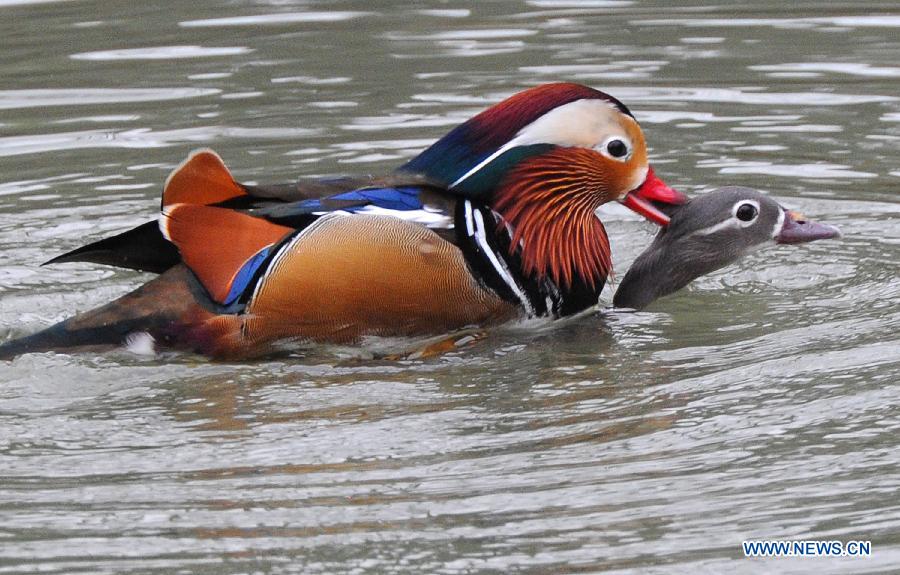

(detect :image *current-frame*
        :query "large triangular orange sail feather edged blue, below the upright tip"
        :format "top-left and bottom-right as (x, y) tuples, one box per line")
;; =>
(159, 204), (294, 303)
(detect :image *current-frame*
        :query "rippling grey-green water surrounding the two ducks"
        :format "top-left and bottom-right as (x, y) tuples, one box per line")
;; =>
(0, 0), (900, 574)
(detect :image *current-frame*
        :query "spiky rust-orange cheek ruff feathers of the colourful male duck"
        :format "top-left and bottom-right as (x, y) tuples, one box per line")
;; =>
(496, 148), (624, 288)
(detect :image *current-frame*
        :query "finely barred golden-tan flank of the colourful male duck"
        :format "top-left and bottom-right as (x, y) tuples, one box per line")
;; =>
(242, 214), (518, 346)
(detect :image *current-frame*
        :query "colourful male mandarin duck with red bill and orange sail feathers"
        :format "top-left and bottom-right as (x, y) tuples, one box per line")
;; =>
(0, 83), (685, 358)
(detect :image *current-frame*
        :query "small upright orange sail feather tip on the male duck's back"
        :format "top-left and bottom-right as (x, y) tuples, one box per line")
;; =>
(162, 149), (246, 208)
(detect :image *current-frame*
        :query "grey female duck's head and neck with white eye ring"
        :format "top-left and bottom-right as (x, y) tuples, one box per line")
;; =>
(613, 187), (840, 309)
